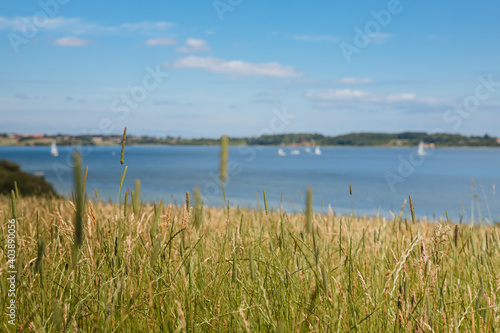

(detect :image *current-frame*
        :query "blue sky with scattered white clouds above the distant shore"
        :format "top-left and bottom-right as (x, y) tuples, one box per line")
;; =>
(0, 0), (500, 137)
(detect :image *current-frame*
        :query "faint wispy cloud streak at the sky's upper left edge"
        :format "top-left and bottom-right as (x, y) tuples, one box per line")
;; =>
(0, 16), (174, 35)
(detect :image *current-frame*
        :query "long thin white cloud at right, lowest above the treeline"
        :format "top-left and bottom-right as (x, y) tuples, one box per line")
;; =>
(306, 89), (450, 105)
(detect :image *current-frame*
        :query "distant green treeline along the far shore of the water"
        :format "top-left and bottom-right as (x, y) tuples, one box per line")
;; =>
(0, 132), (500, 147)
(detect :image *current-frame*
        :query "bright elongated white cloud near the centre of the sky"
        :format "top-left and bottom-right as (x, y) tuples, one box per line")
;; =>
(171, 56), (302, 77)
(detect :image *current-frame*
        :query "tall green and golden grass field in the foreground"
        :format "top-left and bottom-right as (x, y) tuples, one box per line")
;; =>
(0, 188), (500, 332)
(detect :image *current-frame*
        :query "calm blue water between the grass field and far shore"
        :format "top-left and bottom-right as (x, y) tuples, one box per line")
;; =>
(0, 146), (500, 221)
